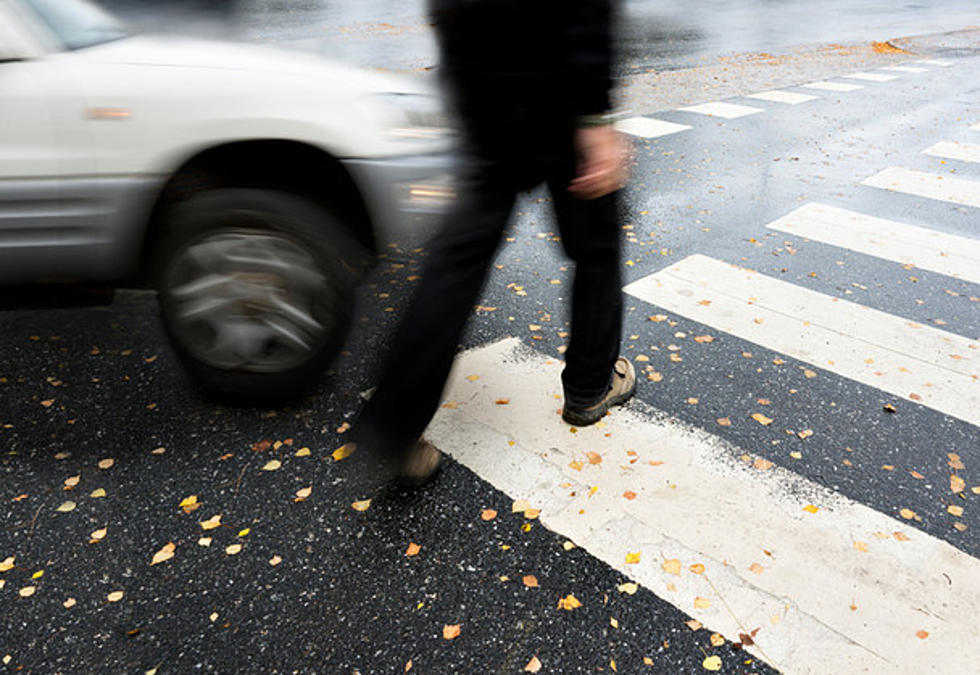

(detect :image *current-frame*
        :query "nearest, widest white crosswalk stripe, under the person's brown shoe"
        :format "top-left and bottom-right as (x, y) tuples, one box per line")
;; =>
(426, 339), (980, 675)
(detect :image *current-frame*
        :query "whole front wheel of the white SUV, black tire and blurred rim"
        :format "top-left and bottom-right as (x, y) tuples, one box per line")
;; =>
(153, 188), (364, 402)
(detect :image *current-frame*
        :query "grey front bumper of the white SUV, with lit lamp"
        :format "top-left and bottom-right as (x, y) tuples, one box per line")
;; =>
(343, 153), (458, 250)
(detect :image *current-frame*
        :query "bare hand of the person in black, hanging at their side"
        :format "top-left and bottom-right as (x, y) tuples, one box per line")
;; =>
(568, 125), (629, 199)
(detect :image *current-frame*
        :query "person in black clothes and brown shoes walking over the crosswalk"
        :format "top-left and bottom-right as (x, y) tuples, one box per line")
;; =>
(355, 0), (636, 484)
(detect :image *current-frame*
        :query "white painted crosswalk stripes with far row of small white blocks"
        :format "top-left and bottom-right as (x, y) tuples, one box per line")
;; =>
(442, 59), (980, 673)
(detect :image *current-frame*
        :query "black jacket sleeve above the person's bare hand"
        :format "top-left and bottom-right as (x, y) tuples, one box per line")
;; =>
(564, 0), (615, 116)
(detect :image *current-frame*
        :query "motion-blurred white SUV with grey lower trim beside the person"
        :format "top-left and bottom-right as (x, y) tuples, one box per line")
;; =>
(0, 0), (452, 398)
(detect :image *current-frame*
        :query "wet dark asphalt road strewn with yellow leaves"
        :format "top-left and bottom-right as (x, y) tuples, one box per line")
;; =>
(0, 5), (980, 673)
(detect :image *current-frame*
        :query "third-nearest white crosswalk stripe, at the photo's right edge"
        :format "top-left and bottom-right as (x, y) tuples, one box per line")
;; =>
(767, 203), (980, 284)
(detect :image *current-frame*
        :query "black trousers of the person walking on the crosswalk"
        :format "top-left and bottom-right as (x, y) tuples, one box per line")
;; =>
(355, 136), (623, 459)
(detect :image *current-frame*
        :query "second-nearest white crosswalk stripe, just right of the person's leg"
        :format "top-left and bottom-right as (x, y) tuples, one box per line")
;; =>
(624, 255), (980, 425)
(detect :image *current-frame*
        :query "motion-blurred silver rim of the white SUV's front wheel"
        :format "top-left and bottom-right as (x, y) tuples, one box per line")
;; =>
(161, 230), (337, 372)
